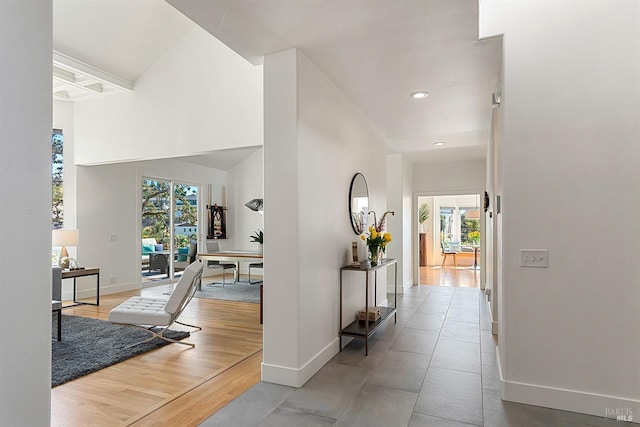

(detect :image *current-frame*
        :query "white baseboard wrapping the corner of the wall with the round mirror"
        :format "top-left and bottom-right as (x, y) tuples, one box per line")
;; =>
(262, 338), (340, 387)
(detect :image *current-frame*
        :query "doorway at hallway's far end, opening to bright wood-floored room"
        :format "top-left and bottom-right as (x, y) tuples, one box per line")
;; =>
(417, 194), (482, 288)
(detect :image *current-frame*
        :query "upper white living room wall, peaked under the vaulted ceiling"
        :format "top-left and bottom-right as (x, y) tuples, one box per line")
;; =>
(70, 27), (262, 165)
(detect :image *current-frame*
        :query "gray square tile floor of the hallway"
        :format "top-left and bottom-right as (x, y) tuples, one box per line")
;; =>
(201, 286), (621, 427)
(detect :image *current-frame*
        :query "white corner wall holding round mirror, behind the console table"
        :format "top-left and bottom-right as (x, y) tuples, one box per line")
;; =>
(262, 50), (386, 386)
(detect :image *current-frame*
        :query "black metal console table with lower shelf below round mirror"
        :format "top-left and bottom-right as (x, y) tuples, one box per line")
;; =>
(339, 258), (398, 356)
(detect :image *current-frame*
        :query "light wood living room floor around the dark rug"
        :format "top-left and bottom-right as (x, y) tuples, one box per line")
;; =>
(51, 276), (262, 427)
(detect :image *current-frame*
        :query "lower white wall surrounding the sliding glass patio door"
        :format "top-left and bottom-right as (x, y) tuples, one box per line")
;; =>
(77, 160), (227, 294)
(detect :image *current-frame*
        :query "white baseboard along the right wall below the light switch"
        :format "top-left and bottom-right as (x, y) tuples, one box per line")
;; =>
(496, 347), (640, 424)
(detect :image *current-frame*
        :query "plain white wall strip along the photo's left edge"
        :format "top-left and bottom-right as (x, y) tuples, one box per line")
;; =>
(0, 0), (52, 427)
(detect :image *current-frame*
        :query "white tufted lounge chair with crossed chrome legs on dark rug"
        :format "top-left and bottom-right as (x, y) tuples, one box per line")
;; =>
(109, 261), (204, 348)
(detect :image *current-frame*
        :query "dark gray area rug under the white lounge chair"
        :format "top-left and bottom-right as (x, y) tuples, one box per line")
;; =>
(51, 315), (189, 387)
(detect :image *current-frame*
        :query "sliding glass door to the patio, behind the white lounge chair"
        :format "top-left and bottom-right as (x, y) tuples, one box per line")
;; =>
(140, 177), (198, 284)
